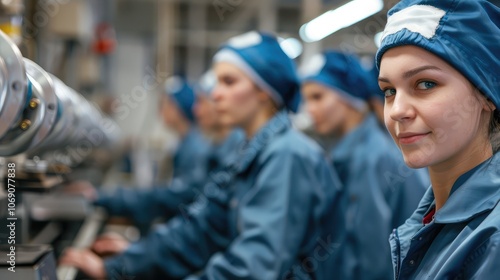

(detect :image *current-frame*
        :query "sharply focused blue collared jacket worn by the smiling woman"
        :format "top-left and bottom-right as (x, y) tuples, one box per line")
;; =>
(390, 154), (500, 280)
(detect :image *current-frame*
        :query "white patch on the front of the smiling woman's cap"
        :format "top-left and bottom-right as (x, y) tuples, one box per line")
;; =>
(381, 5), (446, 41)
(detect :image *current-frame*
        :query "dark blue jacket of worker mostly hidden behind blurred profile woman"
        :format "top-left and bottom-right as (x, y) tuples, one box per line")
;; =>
(94, 131), (244, 233)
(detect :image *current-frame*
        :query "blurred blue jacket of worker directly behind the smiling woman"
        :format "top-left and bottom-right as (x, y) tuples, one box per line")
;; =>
(330, 115), (429, 280)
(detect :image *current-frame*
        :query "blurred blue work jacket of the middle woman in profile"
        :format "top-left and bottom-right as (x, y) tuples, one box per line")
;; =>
(105, 112), (344, 280)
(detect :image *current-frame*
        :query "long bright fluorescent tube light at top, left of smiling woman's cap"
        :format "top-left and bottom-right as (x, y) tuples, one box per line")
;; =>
(299, 0), (384, 42)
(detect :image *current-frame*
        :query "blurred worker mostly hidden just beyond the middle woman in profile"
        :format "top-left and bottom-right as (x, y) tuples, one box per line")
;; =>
(86, 71), (244, 255)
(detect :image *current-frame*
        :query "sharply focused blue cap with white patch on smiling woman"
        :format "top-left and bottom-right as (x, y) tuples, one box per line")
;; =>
(376, 0), (500, 108)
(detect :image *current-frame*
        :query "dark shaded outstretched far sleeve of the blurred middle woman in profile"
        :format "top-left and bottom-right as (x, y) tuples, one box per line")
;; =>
(104, 182), (229, 279)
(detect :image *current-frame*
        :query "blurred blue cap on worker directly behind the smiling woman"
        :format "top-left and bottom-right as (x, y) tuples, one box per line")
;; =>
(301, 51), (370, 111)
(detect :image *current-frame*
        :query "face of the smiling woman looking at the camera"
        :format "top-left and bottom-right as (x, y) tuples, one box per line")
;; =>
(379, 46), (491, 168)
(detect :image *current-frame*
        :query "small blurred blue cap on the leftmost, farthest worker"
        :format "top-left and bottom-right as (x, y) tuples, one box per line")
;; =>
(165, 76), (195, 122)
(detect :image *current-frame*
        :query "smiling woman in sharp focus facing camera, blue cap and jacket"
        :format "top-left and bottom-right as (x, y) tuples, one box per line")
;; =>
(377, 0), (500, 279)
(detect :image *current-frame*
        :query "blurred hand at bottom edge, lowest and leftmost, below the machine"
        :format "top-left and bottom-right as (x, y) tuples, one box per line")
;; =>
(59, 249), (106, 279)
